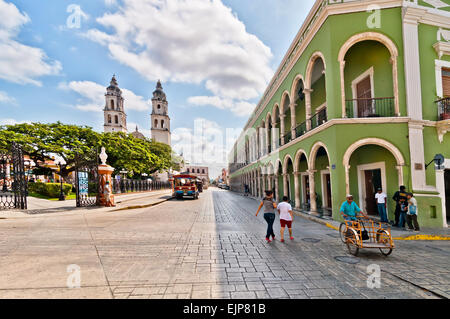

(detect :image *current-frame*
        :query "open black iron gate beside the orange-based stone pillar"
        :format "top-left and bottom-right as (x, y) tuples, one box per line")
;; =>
(75, 150), (100, 207)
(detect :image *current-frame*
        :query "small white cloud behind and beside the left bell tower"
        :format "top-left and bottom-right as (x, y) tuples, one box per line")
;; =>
(59, 81), (149, 112)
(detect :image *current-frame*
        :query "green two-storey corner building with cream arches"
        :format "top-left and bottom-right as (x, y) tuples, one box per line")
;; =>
(229, 0), (450, 228)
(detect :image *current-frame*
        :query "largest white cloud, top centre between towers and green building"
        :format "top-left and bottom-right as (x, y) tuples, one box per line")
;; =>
(85, 0), (273, 115)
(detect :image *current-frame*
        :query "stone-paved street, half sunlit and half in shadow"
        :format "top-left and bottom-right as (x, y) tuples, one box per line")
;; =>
(0, 189), (450, 299)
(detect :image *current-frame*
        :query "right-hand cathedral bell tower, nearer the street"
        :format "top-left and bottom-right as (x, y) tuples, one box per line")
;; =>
(151, 81), (171, 146)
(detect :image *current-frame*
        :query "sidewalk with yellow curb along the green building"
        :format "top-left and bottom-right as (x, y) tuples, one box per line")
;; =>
(237, 193), (450, 240)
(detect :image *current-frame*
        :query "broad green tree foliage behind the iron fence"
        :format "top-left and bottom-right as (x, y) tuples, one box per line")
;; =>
(0, 122), (179, 178)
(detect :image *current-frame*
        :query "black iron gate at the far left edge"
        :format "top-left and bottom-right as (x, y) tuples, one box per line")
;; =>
(0, 142), (28, 210)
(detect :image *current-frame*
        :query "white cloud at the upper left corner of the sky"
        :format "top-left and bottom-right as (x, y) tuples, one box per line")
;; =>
(0, 0), (62, 86)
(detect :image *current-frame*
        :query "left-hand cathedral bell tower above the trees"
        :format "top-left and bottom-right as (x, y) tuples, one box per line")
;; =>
(103, 76), (128, 133)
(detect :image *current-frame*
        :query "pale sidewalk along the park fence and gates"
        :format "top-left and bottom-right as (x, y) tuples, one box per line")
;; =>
(0, 190), (172, 219)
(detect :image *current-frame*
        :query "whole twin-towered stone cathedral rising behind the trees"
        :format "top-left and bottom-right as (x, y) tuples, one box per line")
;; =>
(103, 76), (172, 146)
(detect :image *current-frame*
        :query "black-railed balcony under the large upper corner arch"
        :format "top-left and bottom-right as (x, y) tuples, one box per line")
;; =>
(346, 97), (396, 118)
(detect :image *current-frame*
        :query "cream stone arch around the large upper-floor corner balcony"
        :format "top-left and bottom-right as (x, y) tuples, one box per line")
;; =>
(338, 32), (400, 117)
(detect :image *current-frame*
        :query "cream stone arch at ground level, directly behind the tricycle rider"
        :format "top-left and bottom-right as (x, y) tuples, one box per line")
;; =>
(342, 138), (406, 194)
